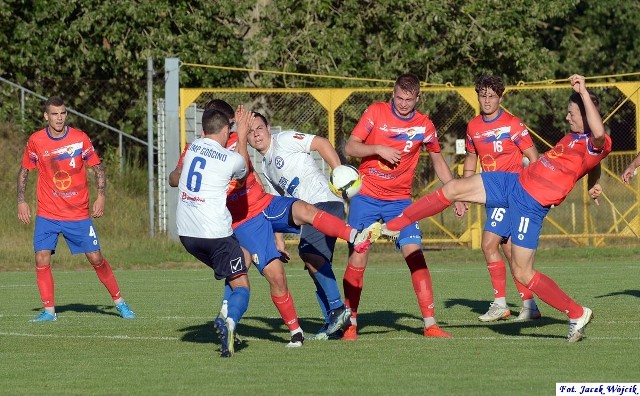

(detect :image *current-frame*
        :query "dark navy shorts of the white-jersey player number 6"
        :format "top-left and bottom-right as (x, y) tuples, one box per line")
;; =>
(180, 235), (247, 279)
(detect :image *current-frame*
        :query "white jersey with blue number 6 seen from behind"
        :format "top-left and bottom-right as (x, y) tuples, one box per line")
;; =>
(176, 137), (247, 238)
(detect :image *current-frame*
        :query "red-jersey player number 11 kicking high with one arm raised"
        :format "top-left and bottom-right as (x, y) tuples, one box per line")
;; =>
(386, 74), (611, 342)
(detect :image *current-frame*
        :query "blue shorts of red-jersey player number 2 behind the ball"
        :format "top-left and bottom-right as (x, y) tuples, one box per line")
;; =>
(347, 194), (422, 247)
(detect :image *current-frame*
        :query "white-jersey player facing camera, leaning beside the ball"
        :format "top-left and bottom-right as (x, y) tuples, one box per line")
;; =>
(247, 112), (351, 339)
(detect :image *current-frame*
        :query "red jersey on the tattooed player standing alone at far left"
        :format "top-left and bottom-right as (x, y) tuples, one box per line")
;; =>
(22, 126), (100, 220)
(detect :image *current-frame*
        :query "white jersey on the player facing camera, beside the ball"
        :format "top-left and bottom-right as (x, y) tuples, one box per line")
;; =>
(262, 131), (342, 204)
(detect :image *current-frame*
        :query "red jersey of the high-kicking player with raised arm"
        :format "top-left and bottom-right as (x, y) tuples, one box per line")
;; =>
(519, 133), (611, 206)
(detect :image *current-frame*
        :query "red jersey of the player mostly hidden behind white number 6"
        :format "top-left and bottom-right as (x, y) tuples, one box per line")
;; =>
(176, 133), (274, 229)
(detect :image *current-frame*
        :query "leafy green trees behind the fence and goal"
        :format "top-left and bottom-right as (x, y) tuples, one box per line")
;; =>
(0, 0), (640, 144)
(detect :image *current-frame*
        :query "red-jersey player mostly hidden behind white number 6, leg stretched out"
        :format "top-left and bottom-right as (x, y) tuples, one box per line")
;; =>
(169, 100), (380, 348)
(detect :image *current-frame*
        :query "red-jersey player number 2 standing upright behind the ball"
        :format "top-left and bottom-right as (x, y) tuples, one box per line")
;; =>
(343, 74), (465, 340)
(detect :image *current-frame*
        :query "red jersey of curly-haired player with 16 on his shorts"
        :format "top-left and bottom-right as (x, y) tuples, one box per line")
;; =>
(466, 110), (533, 173)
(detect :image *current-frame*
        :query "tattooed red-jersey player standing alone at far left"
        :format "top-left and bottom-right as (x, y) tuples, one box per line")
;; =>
(18, 96), (136, 322)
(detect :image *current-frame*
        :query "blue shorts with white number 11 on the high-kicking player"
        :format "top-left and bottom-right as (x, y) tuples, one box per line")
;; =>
(480, 172), (549, 250)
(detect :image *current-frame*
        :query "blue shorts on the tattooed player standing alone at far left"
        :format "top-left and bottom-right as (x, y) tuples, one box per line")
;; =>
(33, 216), (100, 254)
